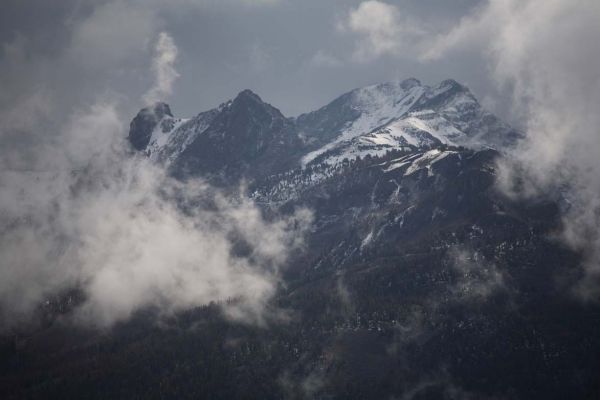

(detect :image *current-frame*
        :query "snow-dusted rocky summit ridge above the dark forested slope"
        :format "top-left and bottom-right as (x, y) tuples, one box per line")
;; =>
(129, 79), (521, 180)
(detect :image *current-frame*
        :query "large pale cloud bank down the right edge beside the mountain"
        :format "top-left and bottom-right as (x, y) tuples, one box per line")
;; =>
(420, 0), (600, 299)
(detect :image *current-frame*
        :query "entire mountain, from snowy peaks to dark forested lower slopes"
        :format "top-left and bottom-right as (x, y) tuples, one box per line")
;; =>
(0, 79), (600, 399)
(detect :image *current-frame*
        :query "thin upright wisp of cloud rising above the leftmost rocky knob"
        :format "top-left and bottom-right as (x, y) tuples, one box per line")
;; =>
(143, 32), (179, 105)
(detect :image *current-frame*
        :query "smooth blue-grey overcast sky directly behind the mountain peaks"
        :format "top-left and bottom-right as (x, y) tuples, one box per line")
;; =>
(0, 0), (496, 116)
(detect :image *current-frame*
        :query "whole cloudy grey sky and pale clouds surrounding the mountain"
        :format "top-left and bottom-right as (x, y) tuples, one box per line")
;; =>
(0, 0), (600, 327)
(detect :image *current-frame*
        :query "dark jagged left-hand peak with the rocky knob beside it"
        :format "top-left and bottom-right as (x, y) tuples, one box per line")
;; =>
(129, 90), (302, 181)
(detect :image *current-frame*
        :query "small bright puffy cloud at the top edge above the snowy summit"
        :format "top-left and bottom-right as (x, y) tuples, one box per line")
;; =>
(338, 0), (424, 62)
